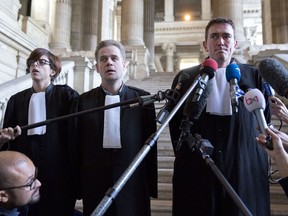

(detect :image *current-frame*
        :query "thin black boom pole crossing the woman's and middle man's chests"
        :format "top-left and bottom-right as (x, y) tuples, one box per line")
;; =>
(15, 90), (168, 130)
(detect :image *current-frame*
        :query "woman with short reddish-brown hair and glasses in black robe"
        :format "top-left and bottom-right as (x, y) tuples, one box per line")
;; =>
(4, 48), (78, 216)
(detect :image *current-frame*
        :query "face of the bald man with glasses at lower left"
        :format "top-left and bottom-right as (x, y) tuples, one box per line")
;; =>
(6, 163), (41, 207)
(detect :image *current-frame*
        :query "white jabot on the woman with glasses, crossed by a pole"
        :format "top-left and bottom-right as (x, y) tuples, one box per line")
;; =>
(27, 92), (46, 135)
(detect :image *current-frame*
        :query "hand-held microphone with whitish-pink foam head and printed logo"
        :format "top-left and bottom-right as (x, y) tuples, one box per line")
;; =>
(244, 89), (273, 150)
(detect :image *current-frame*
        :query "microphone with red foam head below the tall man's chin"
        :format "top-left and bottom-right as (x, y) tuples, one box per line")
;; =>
(192, 58), (218, 102)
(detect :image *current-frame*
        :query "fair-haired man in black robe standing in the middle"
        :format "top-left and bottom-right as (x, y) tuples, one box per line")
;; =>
(72, 40), (157, 216)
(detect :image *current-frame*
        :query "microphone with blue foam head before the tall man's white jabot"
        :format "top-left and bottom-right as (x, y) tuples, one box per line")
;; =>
(226, 64), (244, 113)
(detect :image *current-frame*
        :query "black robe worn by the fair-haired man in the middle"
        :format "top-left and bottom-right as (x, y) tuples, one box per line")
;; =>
(74, 85), (157, 216)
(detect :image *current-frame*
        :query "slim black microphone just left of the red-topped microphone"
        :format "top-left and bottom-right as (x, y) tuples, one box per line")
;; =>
(156, 73), (190, 124)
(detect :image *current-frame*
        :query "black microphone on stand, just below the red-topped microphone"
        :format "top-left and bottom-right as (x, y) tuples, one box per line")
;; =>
(176, 80), (213, 151)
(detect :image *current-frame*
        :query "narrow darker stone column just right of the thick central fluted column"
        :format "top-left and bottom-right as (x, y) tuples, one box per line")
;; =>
(144, 0), (155, 74)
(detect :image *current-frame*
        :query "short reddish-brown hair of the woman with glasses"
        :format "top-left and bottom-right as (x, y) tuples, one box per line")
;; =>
(26, 48), (62, 81)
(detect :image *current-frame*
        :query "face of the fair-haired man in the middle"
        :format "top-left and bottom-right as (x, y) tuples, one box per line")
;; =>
(96, 46), (125, 82)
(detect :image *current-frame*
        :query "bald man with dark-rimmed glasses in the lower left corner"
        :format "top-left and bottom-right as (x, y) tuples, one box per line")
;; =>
(0, 151), (41, 216)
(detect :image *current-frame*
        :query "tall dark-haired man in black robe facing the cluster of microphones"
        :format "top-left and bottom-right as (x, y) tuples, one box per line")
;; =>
(169, 18), (270, 216)
